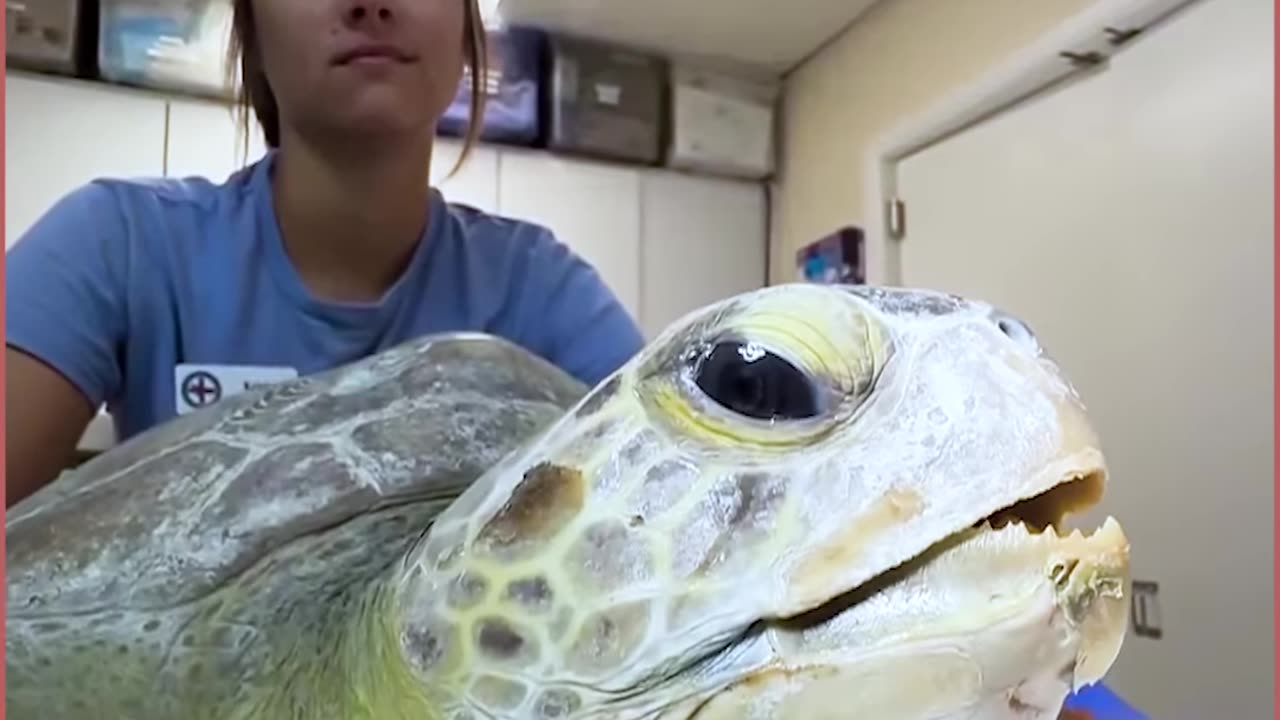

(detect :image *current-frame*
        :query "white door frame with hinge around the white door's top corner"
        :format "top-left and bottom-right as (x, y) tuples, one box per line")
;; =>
(863, 0), (1203, 286)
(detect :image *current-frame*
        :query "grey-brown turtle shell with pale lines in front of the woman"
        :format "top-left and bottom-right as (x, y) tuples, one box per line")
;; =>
(5, 334), (586, 716)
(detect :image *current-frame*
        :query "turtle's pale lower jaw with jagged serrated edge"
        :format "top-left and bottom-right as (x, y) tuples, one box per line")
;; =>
(671, 504), (1129, 720)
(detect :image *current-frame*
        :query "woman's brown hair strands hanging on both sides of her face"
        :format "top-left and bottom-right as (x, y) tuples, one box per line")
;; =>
(227, 0), (489, 177)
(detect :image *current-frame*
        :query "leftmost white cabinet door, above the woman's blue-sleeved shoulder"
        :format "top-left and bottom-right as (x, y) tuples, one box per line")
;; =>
(4, 72), (165, 243)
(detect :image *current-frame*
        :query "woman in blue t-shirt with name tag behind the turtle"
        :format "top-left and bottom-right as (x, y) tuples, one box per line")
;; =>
(5, 0), (643, 506)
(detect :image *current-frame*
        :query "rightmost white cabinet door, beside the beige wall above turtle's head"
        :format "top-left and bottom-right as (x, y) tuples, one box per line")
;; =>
(640, 170), (768, 340)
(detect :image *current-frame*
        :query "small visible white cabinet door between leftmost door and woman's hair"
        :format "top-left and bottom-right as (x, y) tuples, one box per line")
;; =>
(165, 99), (266, 183)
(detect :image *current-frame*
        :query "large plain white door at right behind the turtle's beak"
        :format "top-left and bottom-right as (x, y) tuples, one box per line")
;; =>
(897, 0), (1275, 719)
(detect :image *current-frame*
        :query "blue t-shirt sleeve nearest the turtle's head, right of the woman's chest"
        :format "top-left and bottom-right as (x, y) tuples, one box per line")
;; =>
(521, 229), (644, 384)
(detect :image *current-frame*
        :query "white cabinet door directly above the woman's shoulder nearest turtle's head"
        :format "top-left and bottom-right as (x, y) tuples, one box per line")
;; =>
(498, 150), (640, 318)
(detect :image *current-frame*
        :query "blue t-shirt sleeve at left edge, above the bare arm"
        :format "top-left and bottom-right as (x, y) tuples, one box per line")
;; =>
(5, 183), (129, 407)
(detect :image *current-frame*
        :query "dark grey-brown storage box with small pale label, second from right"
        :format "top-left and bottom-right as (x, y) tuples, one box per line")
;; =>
(547, 36), (667, 164)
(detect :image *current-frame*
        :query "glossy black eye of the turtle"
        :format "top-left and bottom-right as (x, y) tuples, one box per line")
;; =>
(694, 341), (822, 420)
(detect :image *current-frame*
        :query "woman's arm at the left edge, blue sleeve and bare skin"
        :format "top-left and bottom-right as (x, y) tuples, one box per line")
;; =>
(5, 184), (129, 507)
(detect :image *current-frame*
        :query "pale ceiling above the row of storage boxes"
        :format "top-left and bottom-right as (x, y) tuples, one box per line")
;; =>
(488, 0), (877, 74)
